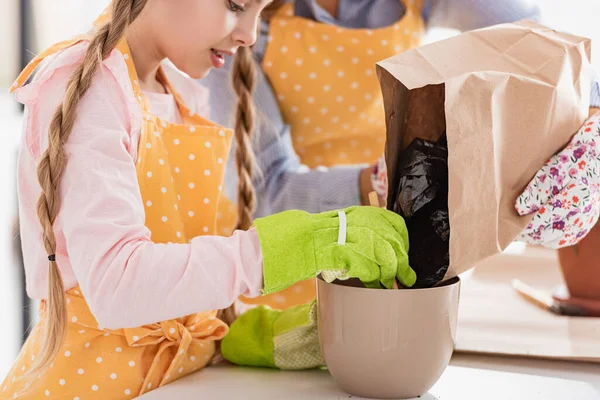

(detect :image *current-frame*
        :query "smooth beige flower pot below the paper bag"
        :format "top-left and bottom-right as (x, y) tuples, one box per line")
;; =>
(317, 278), (460, 399)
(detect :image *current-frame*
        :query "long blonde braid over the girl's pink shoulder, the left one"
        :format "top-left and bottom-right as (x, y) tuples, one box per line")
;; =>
(32, 0), (146, 372)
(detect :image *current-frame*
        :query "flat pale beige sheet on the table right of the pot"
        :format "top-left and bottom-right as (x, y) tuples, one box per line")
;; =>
(456, 247), (600, 363)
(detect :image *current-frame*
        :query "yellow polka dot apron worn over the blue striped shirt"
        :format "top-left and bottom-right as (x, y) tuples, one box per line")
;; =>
(237, 0), (424, 309)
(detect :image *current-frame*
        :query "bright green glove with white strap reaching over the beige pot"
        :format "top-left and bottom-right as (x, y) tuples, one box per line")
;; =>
(255, 207), (416, 294)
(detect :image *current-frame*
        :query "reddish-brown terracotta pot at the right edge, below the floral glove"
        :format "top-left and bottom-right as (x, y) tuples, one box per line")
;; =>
(558, 224), (600, 301)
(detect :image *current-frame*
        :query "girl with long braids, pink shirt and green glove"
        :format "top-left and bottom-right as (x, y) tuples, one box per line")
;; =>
(0, 0), (415, 399)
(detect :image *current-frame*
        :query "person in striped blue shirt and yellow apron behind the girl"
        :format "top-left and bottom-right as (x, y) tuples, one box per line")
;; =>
(200, 0), (600, 309)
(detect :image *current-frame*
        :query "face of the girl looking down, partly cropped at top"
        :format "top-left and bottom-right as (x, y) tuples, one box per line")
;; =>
(144, 0), (270, 79)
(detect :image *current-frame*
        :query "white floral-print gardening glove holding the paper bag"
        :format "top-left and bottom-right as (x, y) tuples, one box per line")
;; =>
(515, 114), (600, 249)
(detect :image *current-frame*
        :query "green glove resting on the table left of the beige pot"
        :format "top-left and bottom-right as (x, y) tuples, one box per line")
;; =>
(221, 301), (325, 370)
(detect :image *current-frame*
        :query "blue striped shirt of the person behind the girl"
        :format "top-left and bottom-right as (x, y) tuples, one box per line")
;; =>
(199, 0), (600, 217)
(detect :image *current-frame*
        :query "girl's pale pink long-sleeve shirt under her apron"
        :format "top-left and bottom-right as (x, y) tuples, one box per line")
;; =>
(15, 43), (262, 329)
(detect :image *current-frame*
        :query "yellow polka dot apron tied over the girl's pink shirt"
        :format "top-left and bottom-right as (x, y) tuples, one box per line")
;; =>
(0, 38), (232, 400)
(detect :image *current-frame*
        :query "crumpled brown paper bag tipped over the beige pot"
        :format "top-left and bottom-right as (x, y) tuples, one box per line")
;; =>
(377, 21), (591, 279)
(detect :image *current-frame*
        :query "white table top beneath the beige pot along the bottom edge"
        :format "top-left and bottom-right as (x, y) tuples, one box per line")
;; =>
(141, 354), (600, 400)
